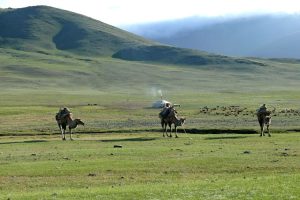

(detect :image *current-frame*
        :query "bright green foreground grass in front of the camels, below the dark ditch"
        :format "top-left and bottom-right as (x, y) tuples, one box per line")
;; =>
(0, 132), (300, 199)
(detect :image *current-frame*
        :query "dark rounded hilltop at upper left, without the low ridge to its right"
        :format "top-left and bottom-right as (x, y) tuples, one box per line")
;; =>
(0, 6), (155, 55)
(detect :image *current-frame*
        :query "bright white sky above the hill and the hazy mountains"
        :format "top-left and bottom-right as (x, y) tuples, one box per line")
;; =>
(0, 0), (300, 26)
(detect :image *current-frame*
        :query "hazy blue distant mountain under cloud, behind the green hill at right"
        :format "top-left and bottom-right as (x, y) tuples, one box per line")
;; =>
(124, 14), (300, 58)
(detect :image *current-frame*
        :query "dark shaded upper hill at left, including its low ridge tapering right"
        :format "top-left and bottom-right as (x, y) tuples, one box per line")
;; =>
(0, 6), (266, 65)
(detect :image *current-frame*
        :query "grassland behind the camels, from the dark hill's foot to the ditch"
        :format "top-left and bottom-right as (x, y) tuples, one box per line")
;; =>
(0, 49), (300, 135)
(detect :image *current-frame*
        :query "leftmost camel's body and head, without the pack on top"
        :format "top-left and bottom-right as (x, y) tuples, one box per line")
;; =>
(55, 113), (84, 140)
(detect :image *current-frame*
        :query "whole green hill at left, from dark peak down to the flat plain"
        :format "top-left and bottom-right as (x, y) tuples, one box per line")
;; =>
(0, 6), (300, 105)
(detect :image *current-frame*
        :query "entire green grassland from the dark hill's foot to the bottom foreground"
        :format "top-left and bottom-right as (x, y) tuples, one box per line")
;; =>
(0, 49), (300, 199)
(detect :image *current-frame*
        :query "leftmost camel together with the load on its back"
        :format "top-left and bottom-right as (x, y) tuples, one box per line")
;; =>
(55, 107), (84, 140)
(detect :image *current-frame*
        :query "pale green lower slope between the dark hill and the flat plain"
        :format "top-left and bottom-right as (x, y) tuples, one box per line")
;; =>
(0, 49), (300, 96)
